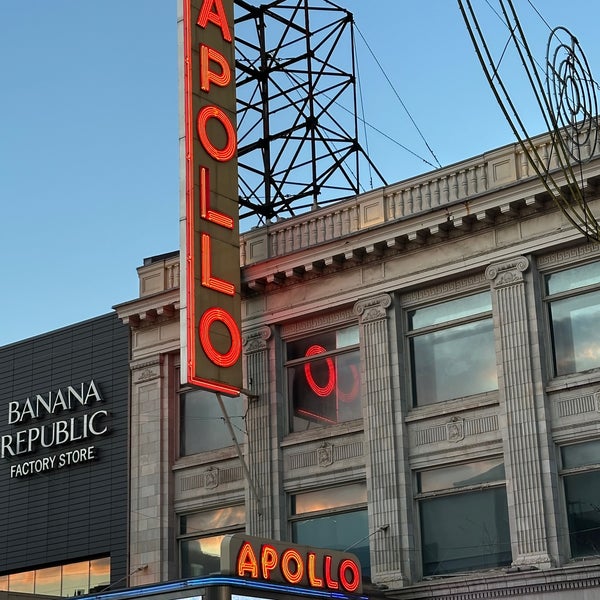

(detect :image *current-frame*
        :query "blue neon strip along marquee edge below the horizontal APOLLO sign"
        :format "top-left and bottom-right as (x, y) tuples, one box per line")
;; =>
(79, 576), (368, 600)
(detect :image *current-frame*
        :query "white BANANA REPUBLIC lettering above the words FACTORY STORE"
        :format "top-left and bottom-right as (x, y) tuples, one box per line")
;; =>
(0, 380), (110, 460)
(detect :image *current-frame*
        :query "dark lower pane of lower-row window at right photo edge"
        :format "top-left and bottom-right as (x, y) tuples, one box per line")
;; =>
(565, 471), (600, 557)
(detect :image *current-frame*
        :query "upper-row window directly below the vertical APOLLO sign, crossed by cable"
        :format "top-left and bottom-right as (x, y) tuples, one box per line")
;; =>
(179, 390), (245, 456)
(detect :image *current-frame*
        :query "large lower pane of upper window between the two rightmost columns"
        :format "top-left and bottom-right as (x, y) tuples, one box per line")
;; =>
(410, 319), (498, 406)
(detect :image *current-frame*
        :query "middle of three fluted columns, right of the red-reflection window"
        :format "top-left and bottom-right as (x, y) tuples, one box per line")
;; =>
(354, 294), (403, 588)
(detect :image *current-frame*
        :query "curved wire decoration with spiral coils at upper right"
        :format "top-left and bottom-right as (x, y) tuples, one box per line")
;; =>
(458, 0), (600, 242)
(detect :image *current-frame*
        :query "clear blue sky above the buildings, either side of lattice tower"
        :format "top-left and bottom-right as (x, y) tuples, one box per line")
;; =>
(0, 0), (600, 346)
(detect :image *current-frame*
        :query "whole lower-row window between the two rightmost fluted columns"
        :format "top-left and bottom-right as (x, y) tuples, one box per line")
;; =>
(417, 459), (512, 576)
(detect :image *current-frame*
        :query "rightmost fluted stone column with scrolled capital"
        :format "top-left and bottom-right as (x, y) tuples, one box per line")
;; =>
(486, 256), (551, 568)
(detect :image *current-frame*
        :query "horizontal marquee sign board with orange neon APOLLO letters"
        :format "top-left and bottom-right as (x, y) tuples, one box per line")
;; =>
(221, 534), (362, 594)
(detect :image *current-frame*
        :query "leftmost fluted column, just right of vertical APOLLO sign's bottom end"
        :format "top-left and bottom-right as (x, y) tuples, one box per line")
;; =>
(243, 327), (273, 538)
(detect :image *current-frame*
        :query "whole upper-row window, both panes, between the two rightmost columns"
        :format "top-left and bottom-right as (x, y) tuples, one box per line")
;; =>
(407, 291), (498, 406)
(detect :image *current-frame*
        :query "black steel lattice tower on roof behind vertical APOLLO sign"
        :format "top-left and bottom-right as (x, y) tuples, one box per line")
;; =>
(235, 0), (385, 225)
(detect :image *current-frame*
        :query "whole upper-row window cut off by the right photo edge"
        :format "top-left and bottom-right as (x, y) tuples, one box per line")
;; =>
(546, 262), (600, 375)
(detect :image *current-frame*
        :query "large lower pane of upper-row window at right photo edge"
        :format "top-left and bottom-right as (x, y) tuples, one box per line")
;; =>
(550, 291), (600, 375)
